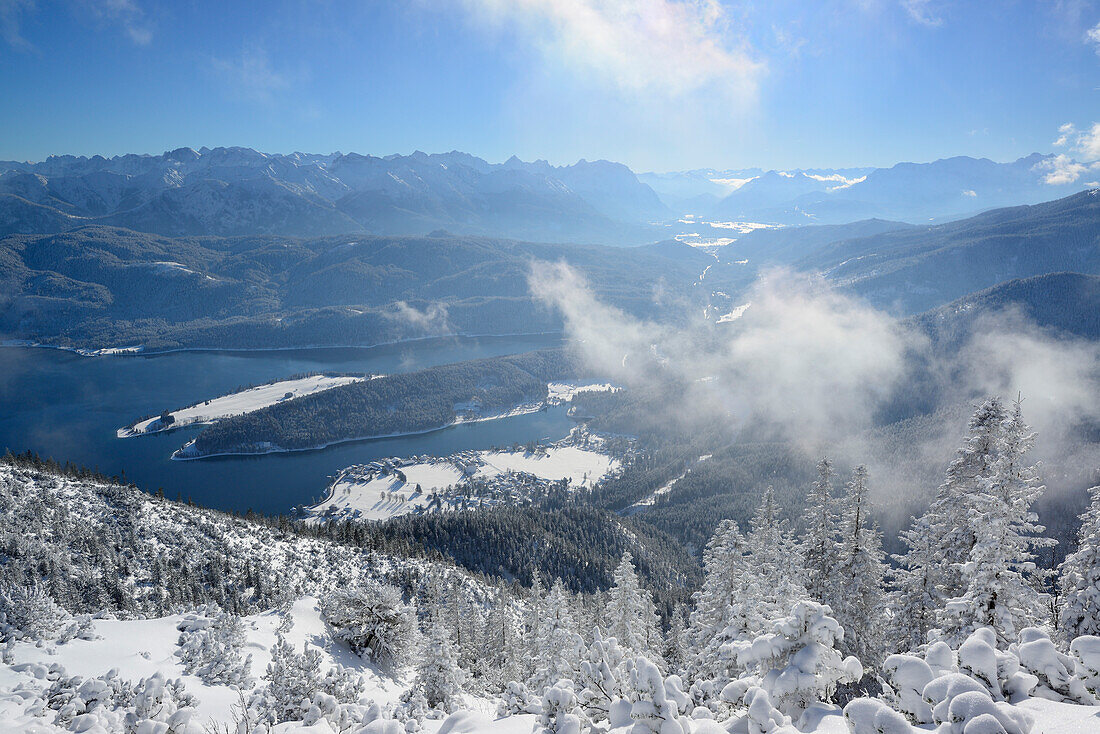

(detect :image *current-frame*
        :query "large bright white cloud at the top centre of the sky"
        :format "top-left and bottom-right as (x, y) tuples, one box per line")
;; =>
(453, 0), (763, 96)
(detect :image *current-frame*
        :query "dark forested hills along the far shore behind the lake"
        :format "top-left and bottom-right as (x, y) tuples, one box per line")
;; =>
(0, 227), (713, 350)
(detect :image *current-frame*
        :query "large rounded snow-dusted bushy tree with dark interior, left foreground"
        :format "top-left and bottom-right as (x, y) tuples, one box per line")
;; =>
(321, 581), (417, 672)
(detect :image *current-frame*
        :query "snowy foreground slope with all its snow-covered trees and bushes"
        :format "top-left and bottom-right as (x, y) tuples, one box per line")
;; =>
(0, 398), (1100, 734)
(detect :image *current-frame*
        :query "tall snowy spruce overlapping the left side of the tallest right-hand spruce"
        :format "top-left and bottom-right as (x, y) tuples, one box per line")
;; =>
(924, 397), (1009, 599)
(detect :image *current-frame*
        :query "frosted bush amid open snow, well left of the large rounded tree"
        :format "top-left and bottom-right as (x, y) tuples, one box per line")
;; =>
(176, 610), (254, 688)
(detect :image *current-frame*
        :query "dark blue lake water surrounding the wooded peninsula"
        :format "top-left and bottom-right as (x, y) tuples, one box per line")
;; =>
(0, 337), (573, 514)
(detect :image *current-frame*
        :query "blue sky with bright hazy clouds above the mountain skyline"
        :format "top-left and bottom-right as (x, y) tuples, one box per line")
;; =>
(0, 0), (1100, 171)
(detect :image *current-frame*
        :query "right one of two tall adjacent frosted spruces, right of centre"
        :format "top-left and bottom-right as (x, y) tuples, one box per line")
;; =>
(832, 465), (887, 667)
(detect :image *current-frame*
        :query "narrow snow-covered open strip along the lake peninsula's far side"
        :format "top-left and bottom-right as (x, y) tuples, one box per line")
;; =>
(118, 374), (366, 438)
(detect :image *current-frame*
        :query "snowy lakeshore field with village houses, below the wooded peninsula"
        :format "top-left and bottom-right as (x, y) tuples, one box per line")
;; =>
(308, 446), (619, 521)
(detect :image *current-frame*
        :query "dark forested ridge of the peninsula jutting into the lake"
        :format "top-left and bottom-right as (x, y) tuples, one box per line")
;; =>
(189, 349), (583, 458)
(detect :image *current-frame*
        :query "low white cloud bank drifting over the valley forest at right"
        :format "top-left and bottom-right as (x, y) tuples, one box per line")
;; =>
(529, 263), (1100, 513)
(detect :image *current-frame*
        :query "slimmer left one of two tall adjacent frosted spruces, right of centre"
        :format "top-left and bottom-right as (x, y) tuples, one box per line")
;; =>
(802, 458), (839, 604)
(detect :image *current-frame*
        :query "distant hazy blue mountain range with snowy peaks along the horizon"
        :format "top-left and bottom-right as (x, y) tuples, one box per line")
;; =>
(0, 147), (1087, 244)
